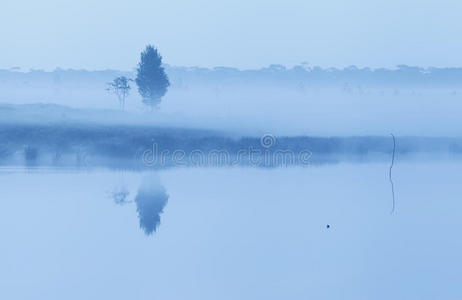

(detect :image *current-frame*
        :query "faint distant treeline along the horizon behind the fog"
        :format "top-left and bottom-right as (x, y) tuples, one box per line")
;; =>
(0, 65), (462, 89)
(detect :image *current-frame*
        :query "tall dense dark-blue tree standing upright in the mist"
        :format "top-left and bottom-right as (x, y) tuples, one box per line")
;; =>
(135, 45), (170, 110)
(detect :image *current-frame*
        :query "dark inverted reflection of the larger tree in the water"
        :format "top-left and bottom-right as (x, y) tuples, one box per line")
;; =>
(135, 179), (168, 235)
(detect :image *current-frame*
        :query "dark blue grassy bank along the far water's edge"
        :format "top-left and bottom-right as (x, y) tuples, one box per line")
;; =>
(0, 124), (462, 168)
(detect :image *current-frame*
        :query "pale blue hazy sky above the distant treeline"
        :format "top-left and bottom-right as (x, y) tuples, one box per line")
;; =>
(0, 0), (462, 70)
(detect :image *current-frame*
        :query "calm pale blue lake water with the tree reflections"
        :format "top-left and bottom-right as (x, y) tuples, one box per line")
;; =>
(0, 161), (462, 300)
